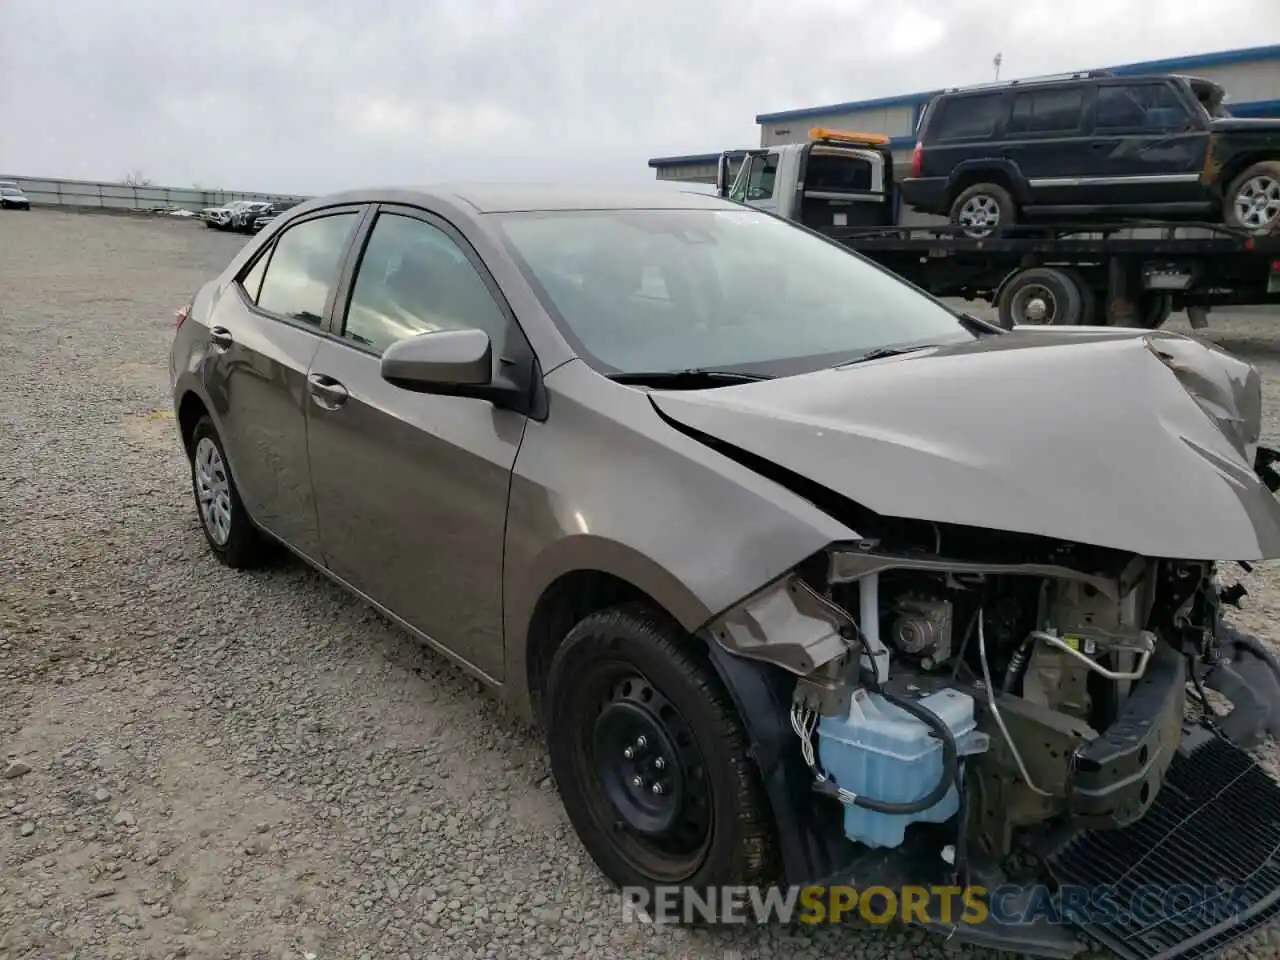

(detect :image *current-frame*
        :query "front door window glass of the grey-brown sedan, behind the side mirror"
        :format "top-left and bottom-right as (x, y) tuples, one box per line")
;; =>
(343, 214), (507, 361)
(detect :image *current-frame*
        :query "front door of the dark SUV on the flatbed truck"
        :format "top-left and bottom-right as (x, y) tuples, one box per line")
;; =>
(1083, 79), (1208, 205)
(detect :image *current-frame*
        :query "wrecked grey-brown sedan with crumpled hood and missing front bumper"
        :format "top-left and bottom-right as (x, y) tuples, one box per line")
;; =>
(172, 187), (1280, 957)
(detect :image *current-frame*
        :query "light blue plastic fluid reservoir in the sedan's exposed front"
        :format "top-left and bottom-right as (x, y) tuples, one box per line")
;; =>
(818, 690), (988, 847)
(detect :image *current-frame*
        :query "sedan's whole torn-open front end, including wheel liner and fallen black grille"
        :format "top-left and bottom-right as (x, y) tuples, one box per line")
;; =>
(708, 522), (1280, 957)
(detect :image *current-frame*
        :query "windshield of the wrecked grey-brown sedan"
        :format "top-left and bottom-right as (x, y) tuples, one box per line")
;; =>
(500, 210), (975, 376)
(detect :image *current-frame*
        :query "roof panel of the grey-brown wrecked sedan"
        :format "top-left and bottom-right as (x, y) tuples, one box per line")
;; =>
(293, 183), (740, 214)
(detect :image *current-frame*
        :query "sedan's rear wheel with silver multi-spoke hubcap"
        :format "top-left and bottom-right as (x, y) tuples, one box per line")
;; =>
(191, 416), (268, 570)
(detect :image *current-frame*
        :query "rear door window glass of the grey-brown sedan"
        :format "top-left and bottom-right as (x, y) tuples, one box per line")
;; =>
(253, 211), (357, 326)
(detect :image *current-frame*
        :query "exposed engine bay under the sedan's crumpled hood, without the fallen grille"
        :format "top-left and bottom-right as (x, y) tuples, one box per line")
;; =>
(713, 525), (1280, 901)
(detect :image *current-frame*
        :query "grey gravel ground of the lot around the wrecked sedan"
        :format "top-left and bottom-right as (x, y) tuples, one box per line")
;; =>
(0, 211), (1280, 960)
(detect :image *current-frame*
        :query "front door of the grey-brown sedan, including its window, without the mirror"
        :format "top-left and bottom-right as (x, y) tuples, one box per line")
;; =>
(307, 207), (525, 680)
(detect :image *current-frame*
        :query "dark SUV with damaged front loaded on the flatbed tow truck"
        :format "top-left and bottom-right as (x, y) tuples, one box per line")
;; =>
(901, 72), (1280, 237)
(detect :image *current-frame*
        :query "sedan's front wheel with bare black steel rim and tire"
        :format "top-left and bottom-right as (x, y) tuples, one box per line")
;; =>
(545, 604), (776, 891)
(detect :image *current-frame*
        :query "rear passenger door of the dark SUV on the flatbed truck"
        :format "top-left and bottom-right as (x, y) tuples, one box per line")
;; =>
(1004, 83), (1097, 206)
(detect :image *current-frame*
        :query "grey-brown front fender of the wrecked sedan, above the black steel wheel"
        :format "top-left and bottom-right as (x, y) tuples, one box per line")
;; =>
(503, 360), (856, 716)
